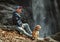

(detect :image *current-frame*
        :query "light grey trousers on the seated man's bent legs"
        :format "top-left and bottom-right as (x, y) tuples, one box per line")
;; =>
(16, 23), (32, 37)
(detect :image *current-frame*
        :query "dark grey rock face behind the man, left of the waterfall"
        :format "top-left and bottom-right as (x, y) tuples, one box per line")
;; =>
(0, 0), (34, 27)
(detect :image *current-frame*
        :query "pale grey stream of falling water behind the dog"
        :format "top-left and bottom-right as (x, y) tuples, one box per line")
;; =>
(32, 0), (49, 37)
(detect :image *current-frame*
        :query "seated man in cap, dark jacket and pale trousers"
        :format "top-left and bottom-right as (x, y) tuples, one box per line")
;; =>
(13, 6), (32, 37)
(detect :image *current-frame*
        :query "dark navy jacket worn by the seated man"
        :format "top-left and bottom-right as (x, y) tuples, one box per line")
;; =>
(12, 12), (22, 27)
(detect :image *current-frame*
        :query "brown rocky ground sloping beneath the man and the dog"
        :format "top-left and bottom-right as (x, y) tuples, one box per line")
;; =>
(0, 28), (58, 42)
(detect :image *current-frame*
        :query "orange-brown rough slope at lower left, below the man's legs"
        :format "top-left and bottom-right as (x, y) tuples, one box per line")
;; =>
(0, 29), (32, 42)
